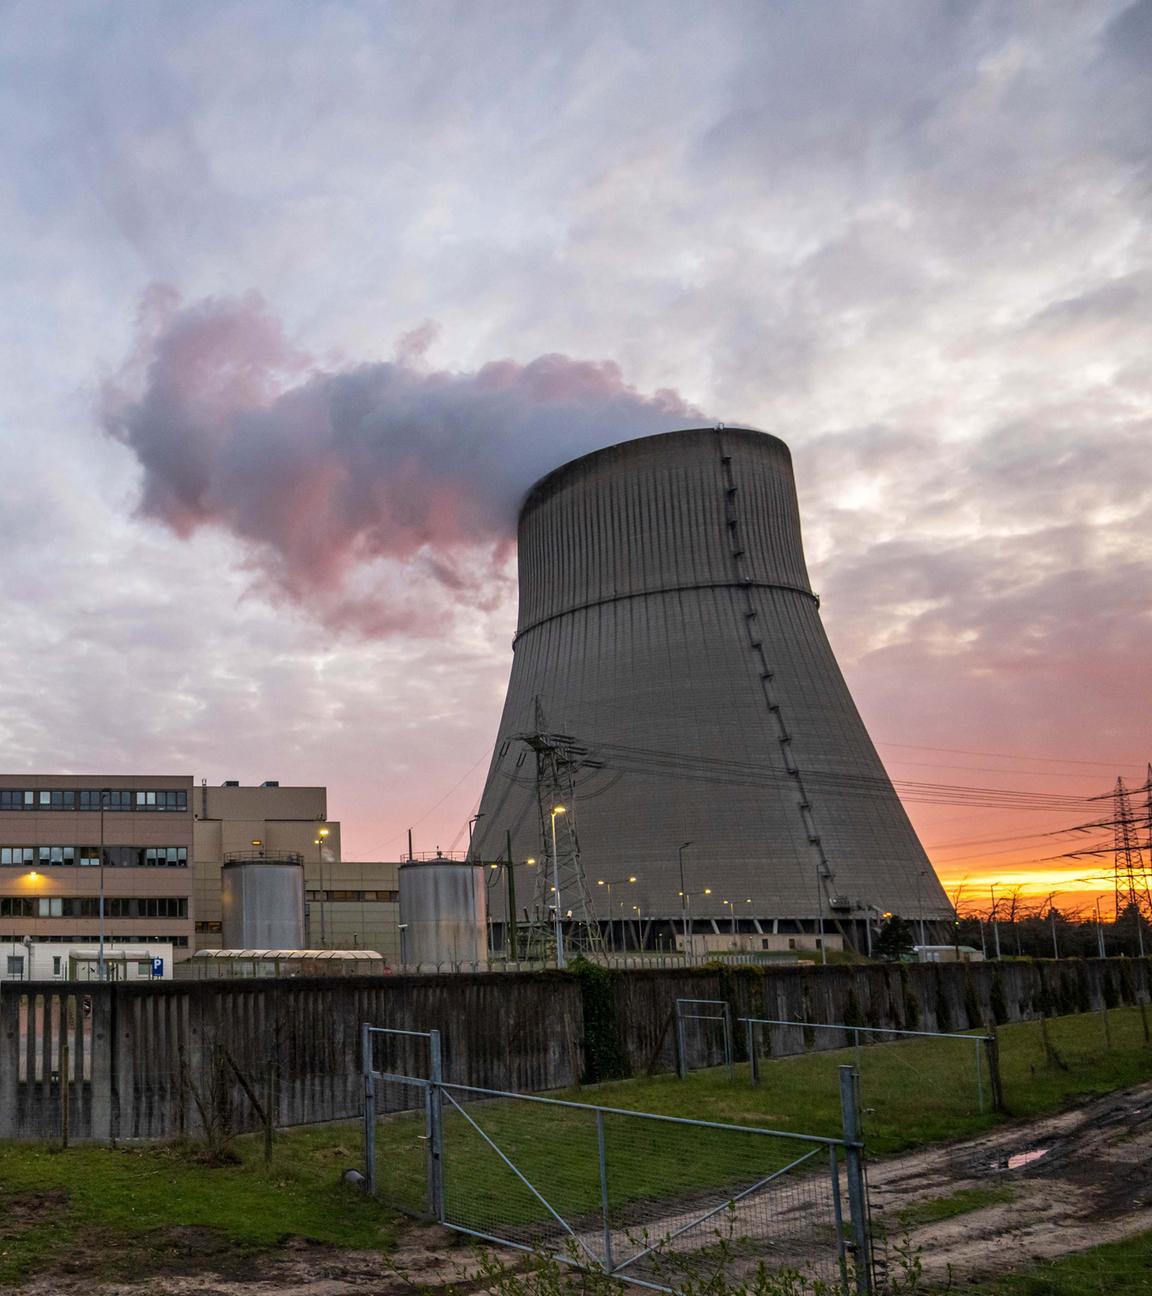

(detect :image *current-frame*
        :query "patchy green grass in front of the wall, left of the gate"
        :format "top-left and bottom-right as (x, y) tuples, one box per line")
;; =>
(0, 1126), (395, 1283)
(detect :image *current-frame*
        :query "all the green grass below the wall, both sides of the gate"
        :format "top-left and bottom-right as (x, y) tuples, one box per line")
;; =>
(0, 1010), (1152, 1296)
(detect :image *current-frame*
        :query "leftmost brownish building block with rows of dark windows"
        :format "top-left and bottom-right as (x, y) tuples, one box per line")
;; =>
(0, 775), (194, 977)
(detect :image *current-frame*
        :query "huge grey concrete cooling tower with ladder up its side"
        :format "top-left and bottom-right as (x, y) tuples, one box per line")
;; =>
(473, 428), (951, 951)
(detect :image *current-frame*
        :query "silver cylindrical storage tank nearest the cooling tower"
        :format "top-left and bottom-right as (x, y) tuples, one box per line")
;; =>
(399, 859), (489, 967)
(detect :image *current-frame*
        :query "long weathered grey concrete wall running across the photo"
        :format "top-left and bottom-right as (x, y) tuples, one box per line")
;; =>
(0, 959), (1152, 1140)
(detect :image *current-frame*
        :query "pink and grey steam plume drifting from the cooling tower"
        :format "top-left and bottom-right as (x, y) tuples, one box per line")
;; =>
(102, 286), (698, 632)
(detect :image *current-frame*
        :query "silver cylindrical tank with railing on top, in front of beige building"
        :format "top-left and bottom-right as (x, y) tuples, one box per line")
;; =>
(220, 855), (305, 950)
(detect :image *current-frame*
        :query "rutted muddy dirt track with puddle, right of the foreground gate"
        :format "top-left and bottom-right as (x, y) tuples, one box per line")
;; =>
(868, 1083), (1152, 1280)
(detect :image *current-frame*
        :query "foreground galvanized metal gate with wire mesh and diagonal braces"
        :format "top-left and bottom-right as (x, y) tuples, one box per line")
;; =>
(363, 1026), (872, 1293)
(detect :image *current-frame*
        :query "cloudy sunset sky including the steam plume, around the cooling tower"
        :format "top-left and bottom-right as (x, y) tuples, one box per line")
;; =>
(0, 0), (1152, 905)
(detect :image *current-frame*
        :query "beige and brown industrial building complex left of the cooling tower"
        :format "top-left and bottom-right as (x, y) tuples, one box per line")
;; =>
(0, 775), (400, 980)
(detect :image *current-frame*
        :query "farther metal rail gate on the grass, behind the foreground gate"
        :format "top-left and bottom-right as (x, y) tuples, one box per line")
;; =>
(739, 1017), (1002, 1120)
